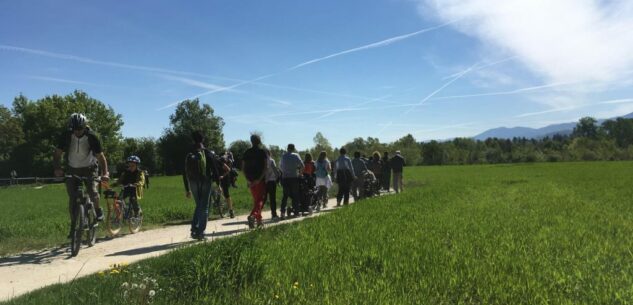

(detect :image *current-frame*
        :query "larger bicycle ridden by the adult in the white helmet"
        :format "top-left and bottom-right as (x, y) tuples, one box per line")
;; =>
(64, 175), (101, 256)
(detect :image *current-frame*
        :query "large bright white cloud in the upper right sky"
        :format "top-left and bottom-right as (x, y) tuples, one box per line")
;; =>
(419, 0), (633, 85)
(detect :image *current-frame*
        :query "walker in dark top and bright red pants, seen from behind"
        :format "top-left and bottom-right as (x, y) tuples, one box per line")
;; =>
(242, 134), (268, 229)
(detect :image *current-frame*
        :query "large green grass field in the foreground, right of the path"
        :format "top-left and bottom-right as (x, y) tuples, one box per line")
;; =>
(4, 162), (633, 304)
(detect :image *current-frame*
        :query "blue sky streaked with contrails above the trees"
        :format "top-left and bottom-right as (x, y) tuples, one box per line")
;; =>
(0, 0), (633, 149)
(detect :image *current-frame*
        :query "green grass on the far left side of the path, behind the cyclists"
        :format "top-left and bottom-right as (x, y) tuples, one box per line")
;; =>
(0, 176), (256, 256)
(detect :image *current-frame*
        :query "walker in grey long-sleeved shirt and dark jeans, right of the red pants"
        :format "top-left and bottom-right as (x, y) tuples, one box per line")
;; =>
(279, 143), (303, 219)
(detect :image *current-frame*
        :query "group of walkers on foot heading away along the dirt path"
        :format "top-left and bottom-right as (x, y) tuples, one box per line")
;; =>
(183, 132), (405, 239)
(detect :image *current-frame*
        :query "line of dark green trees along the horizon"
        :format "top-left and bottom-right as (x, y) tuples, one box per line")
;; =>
(0, 91), (633, 177)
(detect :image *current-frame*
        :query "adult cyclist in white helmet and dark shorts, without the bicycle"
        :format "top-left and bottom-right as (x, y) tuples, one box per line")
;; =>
(53, 113), (110, 236)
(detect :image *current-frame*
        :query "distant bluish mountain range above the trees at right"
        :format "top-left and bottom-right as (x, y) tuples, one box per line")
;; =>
(473, 112), (633, 141)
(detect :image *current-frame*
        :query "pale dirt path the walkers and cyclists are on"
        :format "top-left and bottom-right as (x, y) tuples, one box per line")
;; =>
(0, 198), (351, 301)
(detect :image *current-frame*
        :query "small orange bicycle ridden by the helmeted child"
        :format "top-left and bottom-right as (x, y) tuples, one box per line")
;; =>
(103, 185), (143, 237)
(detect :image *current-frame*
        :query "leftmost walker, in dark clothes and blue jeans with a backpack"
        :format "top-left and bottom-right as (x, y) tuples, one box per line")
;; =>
(182, 131), (220, 240)
